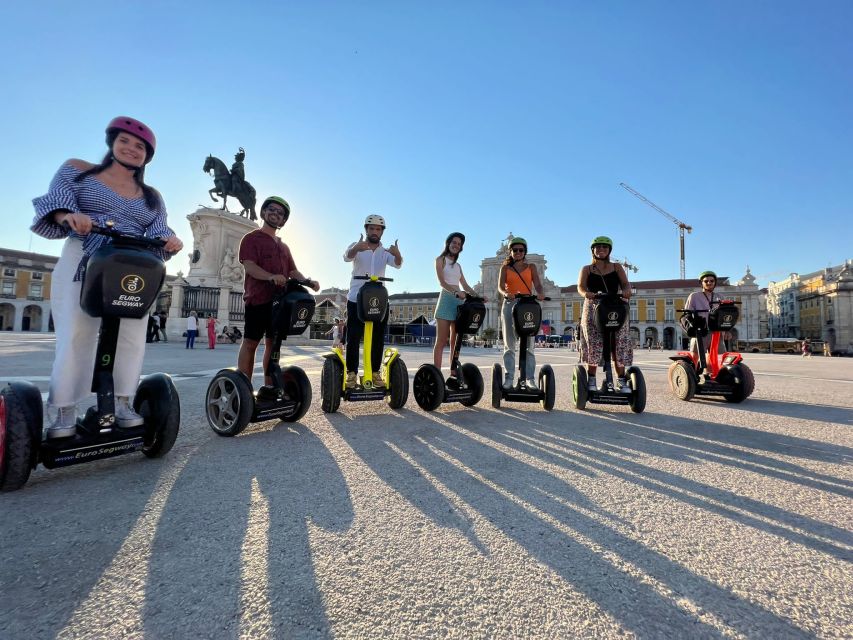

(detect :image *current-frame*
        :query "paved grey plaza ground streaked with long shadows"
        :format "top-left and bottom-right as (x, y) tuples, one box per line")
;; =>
(0, 333), (853, 640)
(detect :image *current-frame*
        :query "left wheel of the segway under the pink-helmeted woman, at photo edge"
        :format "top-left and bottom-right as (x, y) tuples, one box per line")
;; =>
(0, 383), (42, 491)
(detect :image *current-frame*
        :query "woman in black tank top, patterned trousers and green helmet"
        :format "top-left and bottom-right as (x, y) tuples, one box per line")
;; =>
(578, 236), (634, 391)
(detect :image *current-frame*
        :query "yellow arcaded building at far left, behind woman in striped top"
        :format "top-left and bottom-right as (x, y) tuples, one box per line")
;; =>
(0, 248), (58, 331)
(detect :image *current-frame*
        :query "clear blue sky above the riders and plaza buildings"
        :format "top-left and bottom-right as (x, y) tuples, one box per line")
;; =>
(0, 0), (853, 291)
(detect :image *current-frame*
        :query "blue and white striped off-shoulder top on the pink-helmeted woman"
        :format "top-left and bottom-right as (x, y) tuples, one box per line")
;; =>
(30, 163), (175, 280)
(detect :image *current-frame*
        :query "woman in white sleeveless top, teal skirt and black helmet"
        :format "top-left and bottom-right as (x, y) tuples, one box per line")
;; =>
(432, 231), (477, 377)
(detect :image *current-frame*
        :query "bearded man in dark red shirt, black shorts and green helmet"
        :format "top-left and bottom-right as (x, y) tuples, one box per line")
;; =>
(237, 196), (320, 385)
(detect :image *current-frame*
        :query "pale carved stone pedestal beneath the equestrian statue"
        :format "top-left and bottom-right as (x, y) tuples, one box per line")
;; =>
(185, 207), (258, 292)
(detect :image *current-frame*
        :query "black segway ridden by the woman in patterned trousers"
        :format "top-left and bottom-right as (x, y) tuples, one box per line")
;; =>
(572, 294), (646, 413)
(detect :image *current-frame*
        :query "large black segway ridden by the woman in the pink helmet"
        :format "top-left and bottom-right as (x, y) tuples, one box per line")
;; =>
(0, 222), (181, 491)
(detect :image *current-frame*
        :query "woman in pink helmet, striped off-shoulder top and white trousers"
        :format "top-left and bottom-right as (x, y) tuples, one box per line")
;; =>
(30, 116), (183, 438)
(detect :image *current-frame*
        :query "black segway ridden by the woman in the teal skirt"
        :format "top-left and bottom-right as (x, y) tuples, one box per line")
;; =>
(412, 294), (486, 411)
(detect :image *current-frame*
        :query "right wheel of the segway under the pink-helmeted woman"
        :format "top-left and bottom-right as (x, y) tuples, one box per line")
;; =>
(133, 373), (181, 458)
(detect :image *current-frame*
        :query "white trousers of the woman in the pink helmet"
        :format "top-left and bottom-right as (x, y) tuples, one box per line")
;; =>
(47, 238), (148, 407)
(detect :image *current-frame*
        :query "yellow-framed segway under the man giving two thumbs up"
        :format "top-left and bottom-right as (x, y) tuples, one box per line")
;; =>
(320, 276), (409, 413)
